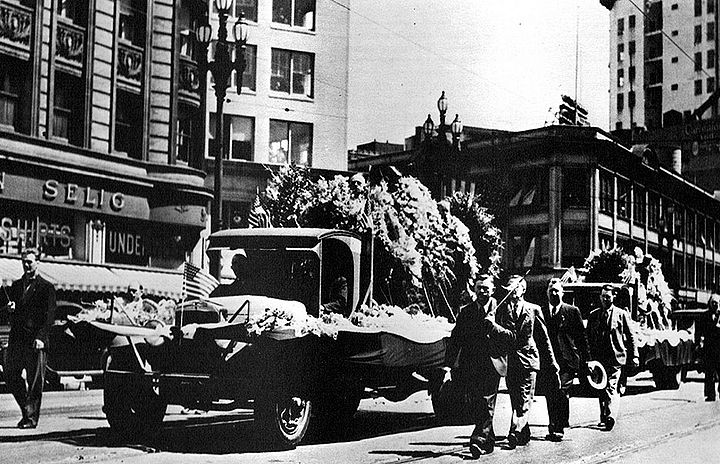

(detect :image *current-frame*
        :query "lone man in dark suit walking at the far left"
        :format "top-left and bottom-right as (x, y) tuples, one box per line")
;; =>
(5, 248), (55, 429)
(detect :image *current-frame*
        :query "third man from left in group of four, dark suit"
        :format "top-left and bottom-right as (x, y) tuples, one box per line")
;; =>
(542, 278), (590, 441)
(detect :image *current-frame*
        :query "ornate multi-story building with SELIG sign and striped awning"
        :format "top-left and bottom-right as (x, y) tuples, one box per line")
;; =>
(0, 0), (212, 299)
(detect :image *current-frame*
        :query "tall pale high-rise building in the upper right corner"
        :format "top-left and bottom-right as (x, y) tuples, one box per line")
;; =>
(603, 0), (718, 130)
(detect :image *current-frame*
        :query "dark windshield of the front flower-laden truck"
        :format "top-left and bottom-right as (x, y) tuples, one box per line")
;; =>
(222, 249), (320, 314)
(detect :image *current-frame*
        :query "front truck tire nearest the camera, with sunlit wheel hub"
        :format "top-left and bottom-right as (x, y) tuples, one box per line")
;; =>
(254, 394), (312, 449)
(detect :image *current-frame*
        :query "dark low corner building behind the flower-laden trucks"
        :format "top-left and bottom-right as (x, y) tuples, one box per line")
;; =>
(350, 126), (720, 302)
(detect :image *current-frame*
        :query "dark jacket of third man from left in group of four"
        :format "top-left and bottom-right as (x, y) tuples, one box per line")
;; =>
(543, 303), (590, 374)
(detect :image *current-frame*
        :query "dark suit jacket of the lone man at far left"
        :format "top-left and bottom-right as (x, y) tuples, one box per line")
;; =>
(8, 275), (55, 348)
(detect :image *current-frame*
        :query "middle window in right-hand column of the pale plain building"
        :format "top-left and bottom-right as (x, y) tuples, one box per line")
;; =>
(270, 48), (314, 98)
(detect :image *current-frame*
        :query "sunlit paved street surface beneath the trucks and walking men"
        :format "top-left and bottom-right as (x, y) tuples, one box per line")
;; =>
(0, 373), (720, 464)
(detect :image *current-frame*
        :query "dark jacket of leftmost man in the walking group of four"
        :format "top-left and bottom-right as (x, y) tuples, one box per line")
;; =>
(445, 298), (515, 382)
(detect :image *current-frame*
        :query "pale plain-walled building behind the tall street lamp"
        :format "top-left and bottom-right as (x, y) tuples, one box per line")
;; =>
(205, 0), (350, 227)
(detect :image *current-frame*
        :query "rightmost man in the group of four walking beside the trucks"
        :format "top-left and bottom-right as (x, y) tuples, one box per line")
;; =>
(587, 285), (639, 431)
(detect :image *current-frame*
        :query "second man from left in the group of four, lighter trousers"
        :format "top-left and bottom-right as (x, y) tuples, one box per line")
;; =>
(496, 275), (541, 449)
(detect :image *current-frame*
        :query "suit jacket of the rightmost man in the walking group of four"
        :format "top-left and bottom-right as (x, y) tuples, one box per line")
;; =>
(587, 305), (638, 367)
